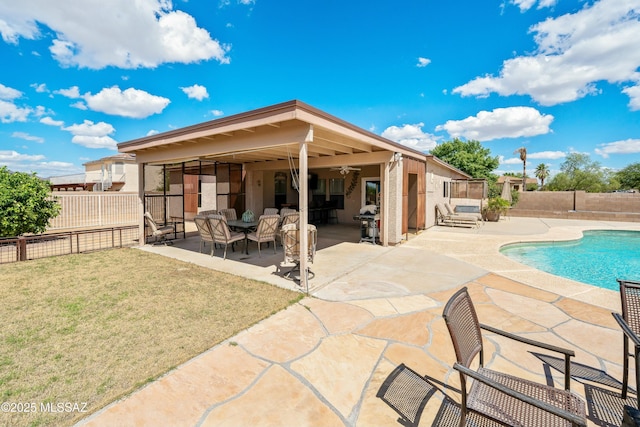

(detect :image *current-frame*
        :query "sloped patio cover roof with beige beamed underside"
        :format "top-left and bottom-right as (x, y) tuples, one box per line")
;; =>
(118, 100), (466, 179)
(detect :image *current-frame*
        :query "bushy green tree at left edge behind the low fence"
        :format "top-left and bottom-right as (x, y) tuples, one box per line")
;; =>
(0, 166), (60, 237)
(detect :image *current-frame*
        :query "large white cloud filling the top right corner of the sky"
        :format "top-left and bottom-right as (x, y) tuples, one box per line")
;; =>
(453, 0), (640, 105)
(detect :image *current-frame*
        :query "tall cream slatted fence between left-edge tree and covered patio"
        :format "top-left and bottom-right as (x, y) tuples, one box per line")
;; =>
(48, 192), (139, 230)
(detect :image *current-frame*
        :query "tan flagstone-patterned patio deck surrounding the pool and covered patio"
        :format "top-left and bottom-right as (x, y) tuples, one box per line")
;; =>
(78, 218), (640, 426)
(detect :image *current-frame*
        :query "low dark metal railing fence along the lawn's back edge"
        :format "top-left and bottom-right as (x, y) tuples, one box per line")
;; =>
(0, 225), (140, 264)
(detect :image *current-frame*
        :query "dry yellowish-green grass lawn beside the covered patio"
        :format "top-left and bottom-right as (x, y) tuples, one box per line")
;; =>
(0, 249), (301, 426)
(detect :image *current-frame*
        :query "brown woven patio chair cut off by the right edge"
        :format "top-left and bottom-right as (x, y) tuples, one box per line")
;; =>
(611, 279), (640, 408)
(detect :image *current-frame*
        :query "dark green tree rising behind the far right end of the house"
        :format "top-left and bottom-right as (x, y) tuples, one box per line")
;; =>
(431, 138), (500, 182)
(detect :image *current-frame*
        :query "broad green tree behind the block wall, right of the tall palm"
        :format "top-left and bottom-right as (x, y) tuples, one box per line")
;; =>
(548, 153), (619, 193)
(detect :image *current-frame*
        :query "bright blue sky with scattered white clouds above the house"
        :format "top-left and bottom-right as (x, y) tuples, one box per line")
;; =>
(0, 0), (640, 177)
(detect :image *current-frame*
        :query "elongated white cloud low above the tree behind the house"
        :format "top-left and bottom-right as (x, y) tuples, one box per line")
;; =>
(436, 107), (553, 141)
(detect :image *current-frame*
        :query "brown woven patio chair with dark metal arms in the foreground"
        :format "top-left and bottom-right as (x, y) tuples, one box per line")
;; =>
(442, 287), (586, 427)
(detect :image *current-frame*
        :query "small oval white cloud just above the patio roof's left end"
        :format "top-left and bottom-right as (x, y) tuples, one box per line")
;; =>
(84, 86), (171, 119)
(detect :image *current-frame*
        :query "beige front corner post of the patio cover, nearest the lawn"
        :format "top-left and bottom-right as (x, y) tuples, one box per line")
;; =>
(298, 125), (313, 294)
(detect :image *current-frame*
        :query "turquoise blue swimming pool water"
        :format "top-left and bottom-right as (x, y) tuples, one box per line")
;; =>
(500, 231), (640, 290)
